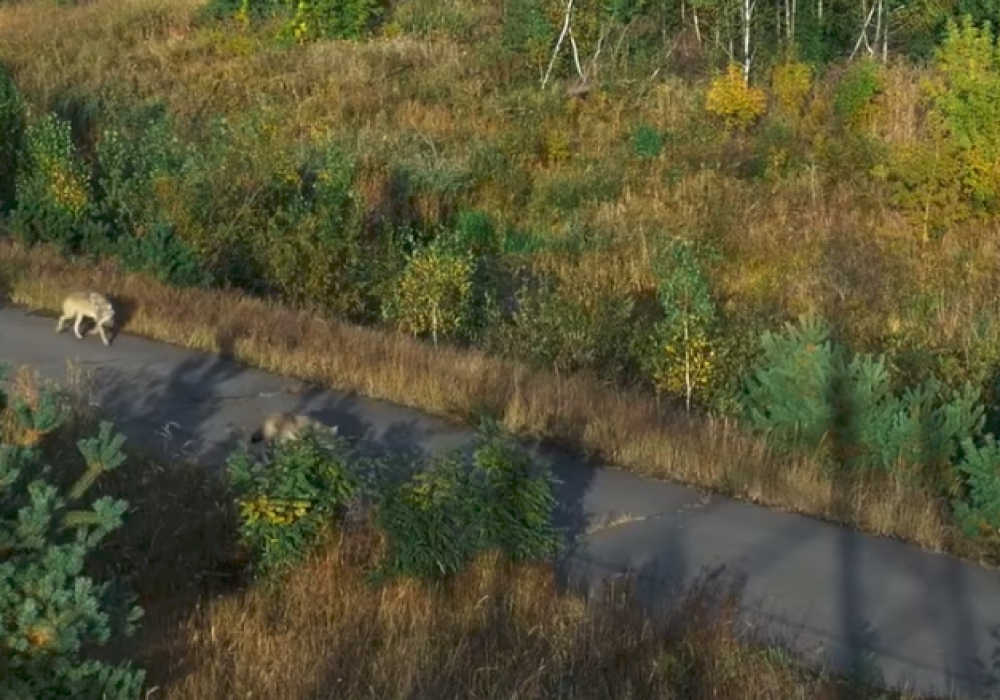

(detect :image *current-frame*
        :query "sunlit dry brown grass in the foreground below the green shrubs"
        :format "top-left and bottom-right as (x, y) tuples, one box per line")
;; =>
(154, 532), (916, 700)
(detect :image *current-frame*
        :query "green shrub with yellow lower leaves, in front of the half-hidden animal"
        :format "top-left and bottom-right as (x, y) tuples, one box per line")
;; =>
(227, 431), (358, 576)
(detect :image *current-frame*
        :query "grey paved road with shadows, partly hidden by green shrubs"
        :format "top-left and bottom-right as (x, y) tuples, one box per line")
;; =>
(0, 308), (1000, 697)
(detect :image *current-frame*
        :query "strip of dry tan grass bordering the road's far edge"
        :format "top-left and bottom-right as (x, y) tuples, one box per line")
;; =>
(0, 243), (982, 558)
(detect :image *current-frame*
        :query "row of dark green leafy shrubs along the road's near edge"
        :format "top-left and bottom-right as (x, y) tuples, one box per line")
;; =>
(229, 426), (558, 578)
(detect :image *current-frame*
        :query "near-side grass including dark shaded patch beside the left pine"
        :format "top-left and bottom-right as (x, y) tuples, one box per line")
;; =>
(0, 370), (928, 700)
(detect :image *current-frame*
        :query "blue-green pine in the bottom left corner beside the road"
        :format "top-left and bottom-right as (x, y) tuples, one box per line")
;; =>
(0, 370), (144, 700)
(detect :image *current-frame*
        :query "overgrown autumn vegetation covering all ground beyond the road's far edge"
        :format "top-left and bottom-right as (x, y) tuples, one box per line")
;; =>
(0, 0), (1000, 568)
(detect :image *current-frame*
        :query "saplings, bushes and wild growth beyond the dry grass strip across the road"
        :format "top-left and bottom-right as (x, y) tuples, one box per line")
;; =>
(0, 0), (1000, 556)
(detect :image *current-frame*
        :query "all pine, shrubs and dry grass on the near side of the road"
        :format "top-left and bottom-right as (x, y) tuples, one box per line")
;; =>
(0, 369), (916, 700)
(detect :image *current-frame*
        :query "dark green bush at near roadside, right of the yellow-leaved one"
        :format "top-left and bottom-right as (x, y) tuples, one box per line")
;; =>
(376, 424), (558, 578)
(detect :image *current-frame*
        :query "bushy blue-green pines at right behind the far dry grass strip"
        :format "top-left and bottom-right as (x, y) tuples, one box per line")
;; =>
(744, 317), (985, 486)
